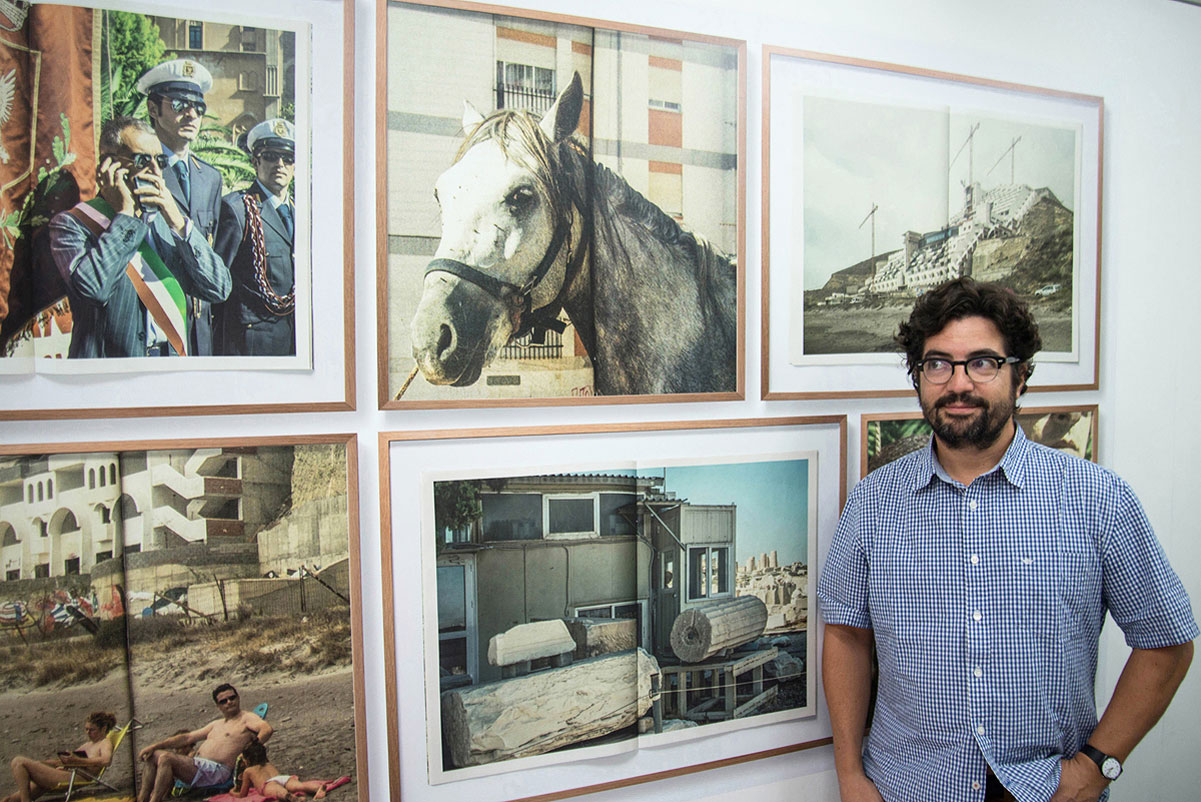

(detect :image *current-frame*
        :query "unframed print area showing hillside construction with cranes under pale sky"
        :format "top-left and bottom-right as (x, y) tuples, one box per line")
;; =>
(789, 95), (1081, 365)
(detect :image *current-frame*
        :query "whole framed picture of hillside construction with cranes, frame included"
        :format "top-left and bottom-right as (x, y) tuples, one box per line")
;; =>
(761, 46), (1104, 399)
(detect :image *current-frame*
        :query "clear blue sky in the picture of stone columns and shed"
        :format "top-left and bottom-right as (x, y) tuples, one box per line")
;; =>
(639, 460), (809, 565)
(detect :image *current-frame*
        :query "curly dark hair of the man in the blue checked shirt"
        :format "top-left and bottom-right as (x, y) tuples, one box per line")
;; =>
(894, 276), (1042, 393)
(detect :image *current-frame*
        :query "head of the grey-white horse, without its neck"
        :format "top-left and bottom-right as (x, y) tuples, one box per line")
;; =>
(412, 73), (584, 387)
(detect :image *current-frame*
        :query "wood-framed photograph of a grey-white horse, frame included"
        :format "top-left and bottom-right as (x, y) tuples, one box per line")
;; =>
(376, 0), (746, 409)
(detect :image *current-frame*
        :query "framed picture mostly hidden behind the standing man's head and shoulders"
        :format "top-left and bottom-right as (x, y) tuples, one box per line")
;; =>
(859, 403), (1098, 478)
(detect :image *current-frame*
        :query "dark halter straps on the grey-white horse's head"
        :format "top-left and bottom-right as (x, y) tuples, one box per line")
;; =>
(425, 201), (592, 343)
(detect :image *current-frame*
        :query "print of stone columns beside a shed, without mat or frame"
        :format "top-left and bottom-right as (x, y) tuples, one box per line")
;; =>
(425, 453), (817, 783)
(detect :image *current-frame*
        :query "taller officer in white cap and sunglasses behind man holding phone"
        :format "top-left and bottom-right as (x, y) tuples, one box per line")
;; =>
(137, 59), (221, 357)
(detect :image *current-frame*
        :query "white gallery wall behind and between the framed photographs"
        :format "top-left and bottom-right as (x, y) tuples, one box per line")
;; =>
(0, 0), (1201, 802)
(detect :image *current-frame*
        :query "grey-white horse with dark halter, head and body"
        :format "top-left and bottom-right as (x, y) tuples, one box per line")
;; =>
(412, 74), (737, 395)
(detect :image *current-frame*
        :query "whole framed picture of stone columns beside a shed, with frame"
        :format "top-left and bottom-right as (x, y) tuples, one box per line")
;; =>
(380, 415), (847, 802)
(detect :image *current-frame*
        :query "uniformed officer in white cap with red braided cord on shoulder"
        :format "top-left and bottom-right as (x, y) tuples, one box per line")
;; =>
(214, 118), (297, 357)
